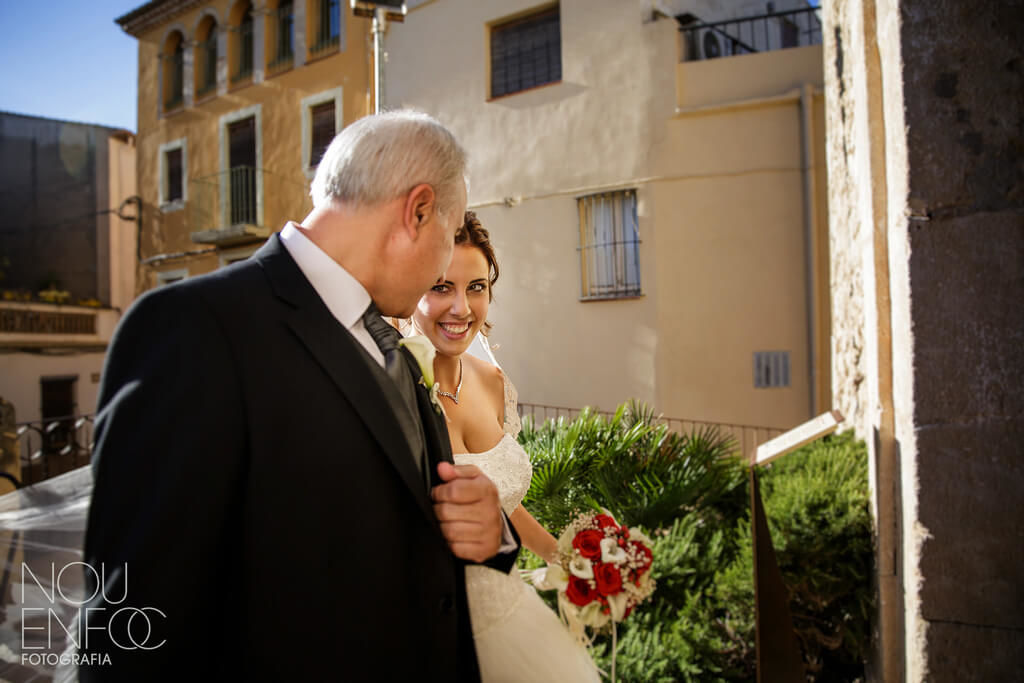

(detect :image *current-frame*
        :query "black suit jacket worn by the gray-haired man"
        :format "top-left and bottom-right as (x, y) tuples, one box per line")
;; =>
(80, 236), (515, 681)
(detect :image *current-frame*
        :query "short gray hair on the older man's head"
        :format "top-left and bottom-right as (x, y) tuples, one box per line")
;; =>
(309, 110), (466, 223)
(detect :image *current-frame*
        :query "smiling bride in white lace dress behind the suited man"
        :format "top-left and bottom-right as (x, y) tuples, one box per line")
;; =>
(413, 211), (599, 683)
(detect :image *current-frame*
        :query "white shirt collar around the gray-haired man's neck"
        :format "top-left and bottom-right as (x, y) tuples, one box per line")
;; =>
(281, 221), (372, 330)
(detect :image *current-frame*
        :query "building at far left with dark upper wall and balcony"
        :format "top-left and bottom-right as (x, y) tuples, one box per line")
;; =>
(0, 113), (137, 490)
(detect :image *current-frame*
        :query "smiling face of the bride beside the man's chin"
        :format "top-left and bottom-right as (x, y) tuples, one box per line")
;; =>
(413, 244), (490, 355)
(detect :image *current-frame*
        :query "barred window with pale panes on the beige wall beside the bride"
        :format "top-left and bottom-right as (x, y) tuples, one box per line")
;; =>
(578, 189), (641, 299)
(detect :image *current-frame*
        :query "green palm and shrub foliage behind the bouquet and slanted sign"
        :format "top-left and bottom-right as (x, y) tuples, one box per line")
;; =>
(519, 403), (873, 683)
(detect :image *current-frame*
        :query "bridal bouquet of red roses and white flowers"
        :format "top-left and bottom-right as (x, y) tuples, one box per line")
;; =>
(534, 510), (654, 635)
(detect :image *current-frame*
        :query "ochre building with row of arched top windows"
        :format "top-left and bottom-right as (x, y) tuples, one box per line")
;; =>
(117, 0), (373, 291)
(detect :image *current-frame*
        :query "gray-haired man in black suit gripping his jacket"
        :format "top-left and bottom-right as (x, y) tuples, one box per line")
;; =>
(79, 112), (518, 681)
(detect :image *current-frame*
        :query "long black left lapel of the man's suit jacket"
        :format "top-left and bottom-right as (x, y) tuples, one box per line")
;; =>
(254, 234), (436, 518)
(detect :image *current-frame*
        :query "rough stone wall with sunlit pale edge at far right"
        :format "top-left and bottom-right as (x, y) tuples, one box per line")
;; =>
(823, 0), (1024, 682)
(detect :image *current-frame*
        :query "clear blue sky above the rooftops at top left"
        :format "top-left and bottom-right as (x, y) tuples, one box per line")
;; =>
(0, 0), (145, 131)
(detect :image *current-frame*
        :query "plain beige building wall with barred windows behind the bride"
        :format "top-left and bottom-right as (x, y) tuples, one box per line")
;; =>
(382, 0), (831, 436)
